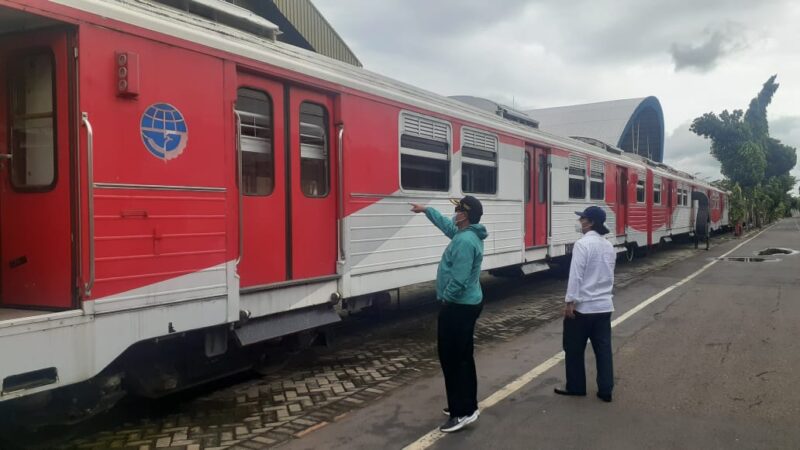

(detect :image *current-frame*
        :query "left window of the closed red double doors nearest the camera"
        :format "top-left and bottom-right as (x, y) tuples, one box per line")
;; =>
(236, 88), (275, 196)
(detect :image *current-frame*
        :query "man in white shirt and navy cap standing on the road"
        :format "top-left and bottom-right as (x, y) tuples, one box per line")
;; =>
(555, 206), (616, 402)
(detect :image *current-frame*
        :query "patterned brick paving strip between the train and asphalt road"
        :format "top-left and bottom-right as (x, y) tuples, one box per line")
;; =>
(4, 229), (752, 450)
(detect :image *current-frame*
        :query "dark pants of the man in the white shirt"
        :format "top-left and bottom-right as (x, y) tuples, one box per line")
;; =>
(564, 312), (614, 395)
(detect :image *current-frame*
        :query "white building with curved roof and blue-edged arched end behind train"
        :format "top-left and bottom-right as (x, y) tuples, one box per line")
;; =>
(525, 96), (664, 162)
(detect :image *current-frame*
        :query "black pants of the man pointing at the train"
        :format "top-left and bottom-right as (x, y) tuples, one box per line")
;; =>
(438, 302), (483, 417)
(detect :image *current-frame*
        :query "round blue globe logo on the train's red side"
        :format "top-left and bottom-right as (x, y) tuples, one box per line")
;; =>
(141, 103), (189, 161)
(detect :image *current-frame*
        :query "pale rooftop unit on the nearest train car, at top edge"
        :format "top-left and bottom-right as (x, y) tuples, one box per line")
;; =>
(155, 0), (281, 41)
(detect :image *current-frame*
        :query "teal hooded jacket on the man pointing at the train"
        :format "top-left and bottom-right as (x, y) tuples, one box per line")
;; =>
(425, 208), (489, 305)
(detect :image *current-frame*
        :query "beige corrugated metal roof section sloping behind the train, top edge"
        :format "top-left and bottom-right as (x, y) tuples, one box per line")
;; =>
(272, 0), (361, 67)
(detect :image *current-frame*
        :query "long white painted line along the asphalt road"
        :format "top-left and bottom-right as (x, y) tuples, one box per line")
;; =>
(403, 224), (774, 450)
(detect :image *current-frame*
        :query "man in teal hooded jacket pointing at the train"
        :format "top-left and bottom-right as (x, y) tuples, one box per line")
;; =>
(411, 195), (488, 433)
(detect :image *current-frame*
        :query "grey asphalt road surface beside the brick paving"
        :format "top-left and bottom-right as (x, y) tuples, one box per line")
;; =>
(284, 219), (800, 449)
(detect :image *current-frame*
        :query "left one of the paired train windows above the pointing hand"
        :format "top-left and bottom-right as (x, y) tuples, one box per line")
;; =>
(400, 113), (451, 192)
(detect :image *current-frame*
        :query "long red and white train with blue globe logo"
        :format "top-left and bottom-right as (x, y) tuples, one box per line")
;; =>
(0, 0), (727, 422)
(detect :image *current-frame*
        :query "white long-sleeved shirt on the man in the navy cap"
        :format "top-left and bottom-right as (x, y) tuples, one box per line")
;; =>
(566, 231), (617, 314)
